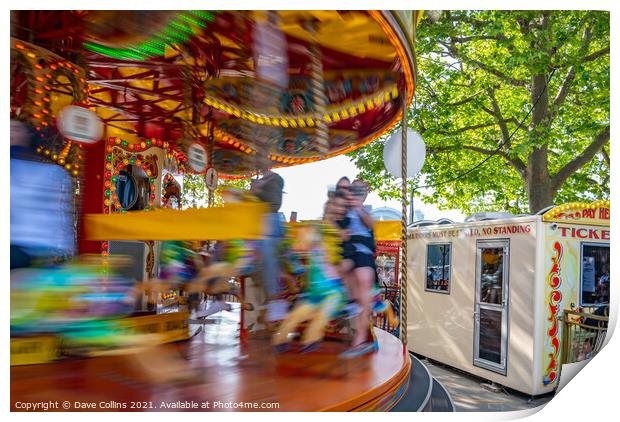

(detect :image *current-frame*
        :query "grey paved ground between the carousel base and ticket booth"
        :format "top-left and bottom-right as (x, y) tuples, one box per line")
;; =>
(422, 359), (553, 412)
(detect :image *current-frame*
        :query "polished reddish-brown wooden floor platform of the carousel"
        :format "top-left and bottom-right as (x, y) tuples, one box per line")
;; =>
(11, 310), (411, 411)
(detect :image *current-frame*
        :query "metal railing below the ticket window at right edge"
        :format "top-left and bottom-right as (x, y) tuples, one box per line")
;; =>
(562, 308), (609, 364)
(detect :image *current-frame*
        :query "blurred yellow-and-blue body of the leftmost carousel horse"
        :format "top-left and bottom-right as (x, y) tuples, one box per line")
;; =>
(11, 262), (136, 353)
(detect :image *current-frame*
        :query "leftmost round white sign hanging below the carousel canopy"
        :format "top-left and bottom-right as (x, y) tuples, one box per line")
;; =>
(57, 105), (103, 144)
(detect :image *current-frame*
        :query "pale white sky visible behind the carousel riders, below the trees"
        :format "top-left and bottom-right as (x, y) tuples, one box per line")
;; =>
(273, 155), (465, 221)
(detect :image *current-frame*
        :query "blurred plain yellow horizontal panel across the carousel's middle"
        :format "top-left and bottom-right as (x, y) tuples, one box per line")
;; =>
(85, 203), (268, 240)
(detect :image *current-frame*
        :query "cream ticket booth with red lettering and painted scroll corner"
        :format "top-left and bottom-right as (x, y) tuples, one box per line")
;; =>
(407, 201), (610, 395)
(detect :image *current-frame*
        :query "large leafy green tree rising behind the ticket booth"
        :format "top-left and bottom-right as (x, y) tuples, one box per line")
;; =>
(350, 11), (610, 213)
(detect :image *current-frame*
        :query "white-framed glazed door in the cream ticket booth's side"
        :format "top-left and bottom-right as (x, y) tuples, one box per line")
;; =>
(474, 240), (509, 375)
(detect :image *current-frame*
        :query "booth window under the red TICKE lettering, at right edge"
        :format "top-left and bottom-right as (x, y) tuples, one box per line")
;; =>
(580, 243), (610, 306)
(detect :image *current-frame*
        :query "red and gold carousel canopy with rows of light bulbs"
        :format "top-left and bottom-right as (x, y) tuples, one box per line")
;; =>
(11, 11), (420, 177)
